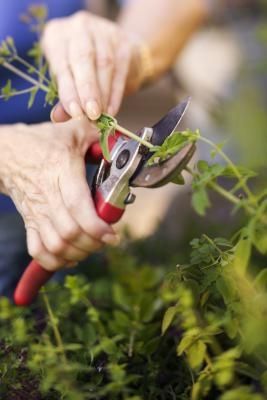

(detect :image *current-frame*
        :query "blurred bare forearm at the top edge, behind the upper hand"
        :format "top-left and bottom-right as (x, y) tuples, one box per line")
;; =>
(118, 0), (208, 78)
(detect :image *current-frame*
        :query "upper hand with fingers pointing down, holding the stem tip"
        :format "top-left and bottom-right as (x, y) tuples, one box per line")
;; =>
(42, 11), (141, 120)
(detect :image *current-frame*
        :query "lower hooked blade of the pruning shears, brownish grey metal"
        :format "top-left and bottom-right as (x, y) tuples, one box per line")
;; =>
(130, 143), (196, 188)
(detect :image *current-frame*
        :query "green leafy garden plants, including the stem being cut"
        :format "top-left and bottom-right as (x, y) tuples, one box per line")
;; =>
(0, 7), (267, 400)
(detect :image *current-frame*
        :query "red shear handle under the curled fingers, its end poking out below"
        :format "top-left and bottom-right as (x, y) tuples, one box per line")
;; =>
(14, 192), (124, 306)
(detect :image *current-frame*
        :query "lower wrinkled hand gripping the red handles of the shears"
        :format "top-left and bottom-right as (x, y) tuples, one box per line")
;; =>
(0, 117), (117, 270)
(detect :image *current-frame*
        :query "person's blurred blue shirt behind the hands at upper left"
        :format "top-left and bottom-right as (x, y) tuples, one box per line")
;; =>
(0, 0), (85, 213)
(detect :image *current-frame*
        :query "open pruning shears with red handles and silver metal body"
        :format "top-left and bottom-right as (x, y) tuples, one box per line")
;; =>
(14, 99), (195, 306)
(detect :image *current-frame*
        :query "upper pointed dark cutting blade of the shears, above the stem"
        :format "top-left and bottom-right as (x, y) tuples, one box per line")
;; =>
(151, 97), (190, 146)
